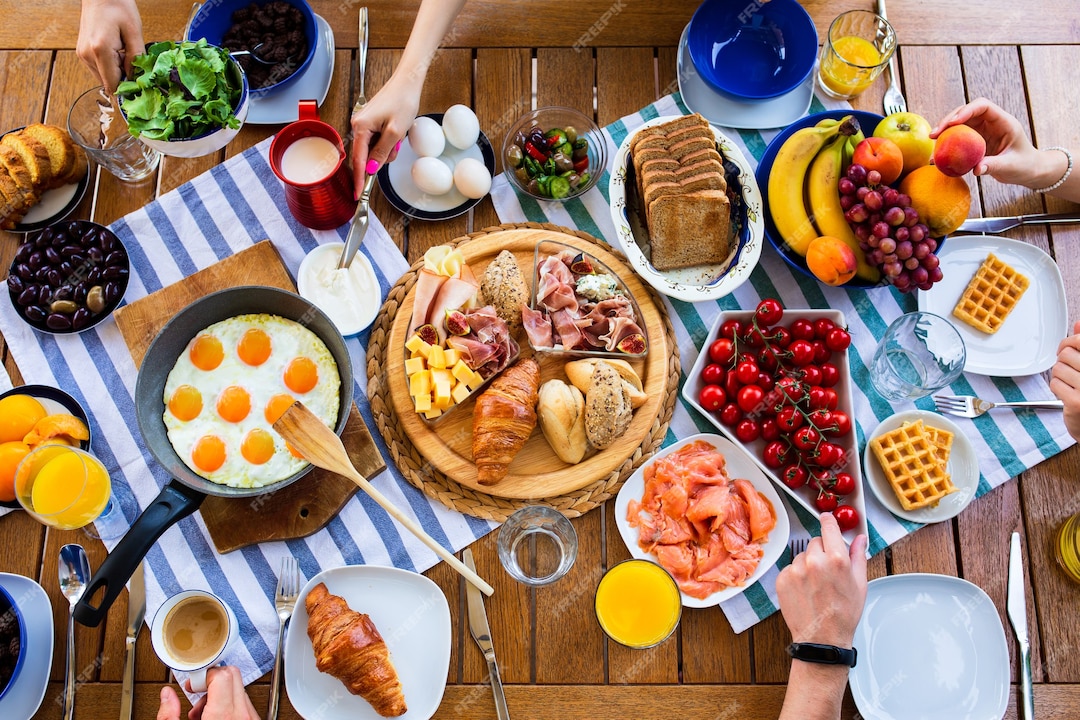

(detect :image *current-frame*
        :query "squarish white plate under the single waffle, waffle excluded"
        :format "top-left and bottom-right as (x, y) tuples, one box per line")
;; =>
(919, 235), (1069, 377)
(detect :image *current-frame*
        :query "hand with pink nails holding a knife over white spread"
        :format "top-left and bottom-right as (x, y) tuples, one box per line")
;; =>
(352, 74), (423, 200)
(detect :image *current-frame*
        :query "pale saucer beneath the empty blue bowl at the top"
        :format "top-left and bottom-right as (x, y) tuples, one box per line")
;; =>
(678, 25), (818, 130)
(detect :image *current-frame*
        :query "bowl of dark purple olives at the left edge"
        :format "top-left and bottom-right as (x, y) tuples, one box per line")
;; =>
(8, 220), (131, 335)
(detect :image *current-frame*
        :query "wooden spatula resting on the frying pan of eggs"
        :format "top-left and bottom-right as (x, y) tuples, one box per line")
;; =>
(273, 402), (495, 595)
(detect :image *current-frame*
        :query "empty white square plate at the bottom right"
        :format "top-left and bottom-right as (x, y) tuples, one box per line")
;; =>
(848, 573), (1010, 720)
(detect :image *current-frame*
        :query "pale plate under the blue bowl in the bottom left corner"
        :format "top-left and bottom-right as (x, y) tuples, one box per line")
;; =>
(0, 572), (53, 718)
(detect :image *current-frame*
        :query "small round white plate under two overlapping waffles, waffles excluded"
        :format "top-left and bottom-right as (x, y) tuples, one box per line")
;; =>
(863, 410), (980, 522)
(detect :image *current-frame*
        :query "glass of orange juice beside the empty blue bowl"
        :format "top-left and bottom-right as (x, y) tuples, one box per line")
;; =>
(818, 10), (896, 100)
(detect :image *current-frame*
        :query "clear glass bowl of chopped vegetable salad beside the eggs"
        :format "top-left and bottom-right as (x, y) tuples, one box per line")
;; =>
(502, 107), (607, 201)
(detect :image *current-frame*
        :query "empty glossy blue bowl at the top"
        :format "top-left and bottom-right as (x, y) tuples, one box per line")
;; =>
(687, 0), (818, 100)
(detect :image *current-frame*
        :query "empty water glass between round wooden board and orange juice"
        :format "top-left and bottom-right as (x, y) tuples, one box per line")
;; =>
(498, 505), (578, 586)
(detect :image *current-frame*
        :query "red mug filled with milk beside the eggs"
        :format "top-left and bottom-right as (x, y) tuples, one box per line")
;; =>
(270, 100), (356, 230)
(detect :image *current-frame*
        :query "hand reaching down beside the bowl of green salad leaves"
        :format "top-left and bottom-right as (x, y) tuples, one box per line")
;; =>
(76, 0), (146, 94)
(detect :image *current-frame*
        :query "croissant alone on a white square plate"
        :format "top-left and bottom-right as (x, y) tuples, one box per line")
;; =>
(305, 583), (408, 718)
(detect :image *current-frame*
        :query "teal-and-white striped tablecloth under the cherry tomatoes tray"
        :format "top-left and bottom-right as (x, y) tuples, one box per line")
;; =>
(491, 88), (1074, 633)
